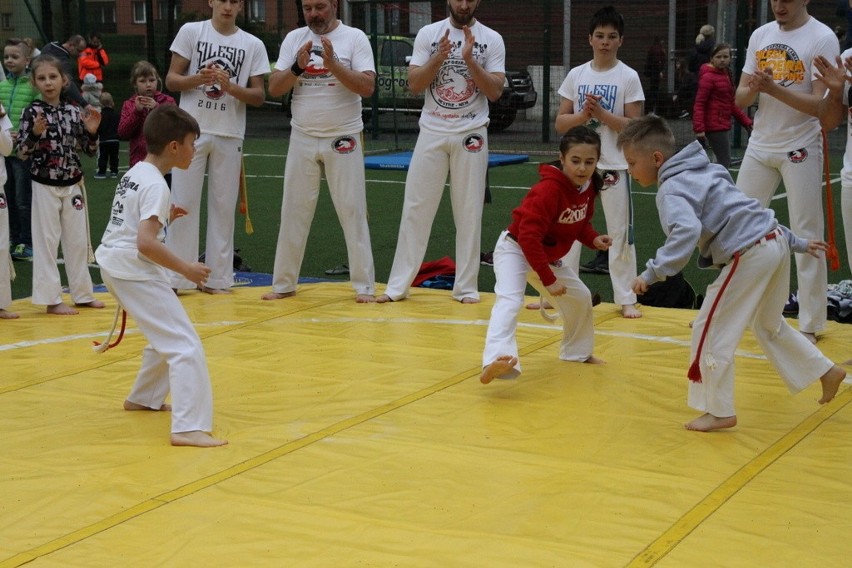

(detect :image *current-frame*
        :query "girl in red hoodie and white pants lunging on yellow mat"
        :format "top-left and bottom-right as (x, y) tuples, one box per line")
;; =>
(479, 126), (612, 384)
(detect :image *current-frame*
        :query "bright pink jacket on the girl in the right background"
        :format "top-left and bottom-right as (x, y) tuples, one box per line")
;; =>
(692, 63), (752, 132)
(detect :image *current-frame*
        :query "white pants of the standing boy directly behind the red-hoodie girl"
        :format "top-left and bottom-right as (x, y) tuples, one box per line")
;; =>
(563, 170), (637, 306)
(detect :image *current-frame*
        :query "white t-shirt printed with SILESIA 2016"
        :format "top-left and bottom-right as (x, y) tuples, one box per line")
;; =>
(169, 20), (269, 139)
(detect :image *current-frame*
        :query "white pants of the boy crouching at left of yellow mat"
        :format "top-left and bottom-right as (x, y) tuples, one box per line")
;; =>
(101, 270), (213, 433)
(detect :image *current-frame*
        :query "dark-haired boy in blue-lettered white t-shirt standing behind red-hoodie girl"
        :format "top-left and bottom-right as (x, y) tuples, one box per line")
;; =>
(556, 6), (645, 318)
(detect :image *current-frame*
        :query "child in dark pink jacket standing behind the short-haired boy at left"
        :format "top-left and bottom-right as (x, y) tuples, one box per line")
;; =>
(118, 61), (175, 170)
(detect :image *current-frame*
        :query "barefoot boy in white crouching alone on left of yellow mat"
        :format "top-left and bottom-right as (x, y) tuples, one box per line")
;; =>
(95, 105), (227, 447)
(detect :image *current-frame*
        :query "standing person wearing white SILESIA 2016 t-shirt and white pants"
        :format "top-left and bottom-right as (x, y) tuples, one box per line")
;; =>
(166, 0), (269, 294)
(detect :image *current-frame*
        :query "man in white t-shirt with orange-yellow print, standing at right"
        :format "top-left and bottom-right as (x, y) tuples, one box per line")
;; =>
(736, 0), (839, 342)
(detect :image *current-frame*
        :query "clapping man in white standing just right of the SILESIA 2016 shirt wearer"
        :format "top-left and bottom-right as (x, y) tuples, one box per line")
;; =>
(262, 0), (376, 303)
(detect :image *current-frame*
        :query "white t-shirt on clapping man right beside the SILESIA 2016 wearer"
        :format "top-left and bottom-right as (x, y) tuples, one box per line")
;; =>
(275, 22), (376, 137)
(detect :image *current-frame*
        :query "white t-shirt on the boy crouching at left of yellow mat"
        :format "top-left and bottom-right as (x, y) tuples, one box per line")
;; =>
(95, 162), (171, 282)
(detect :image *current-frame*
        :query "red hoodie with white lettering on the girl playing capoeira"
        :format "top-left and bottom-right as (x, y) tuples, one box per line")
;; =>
(509, 164), (602, 286)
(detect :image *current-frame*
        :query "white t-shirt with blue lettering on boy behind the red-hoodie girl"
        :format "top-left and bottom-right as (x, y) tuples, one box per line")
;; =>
(558, 61), (645, 170)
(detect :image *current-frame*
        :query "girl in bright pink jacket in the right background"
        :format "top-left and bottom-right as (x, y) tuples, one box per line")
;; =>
(692, 43), (752, 168)
